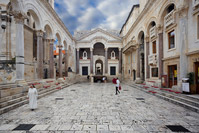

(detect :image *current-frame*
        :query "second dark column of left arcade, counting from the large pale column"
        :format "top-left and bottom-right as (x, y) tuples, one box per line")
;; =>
(49, 39), (54, 78)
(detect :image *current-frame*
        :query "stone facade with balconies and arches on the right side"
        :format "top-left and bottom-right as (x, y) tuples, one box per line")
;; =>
(120, 0), (199, 93)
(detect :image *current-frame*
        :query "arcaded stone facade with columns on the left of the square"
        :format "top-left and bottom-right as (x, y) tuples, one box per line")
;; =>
(0, 0), (76, 84)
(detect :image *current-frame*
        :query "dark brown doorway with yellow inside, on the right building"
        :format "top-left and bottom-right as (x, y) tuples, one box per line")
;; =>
(168, 65), (178, 88)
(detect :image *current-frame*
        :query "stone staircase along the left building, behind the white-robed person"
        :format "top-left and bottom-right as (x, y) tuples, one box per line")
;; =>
(0, 79), (74, 114)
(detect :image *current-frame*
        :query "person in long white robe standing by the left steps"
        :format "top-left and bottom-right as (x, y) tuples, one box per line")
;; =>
(27, 85), (38, 111)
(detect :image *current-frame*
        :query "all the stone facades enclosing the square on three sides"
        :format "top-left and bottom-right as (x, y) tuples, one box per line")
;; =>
(0, 0), (199, 93)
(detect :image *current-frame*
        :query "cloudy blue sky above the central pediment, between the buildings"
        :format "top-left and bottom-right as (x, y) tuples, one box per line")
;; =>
(55, 0), (139, 34)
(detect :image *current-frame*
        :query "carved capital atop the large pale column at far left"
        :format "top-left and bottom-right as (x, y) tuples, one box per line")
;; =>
(11, 11), (27, 24)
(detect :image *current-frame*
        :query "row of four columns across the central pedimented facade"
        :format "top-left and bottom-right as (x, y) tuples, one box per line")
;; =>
(76, 48), (122, 74)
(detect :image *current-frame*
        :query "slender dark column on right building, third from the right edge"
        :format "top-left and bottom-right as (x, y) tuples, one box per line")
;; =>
(145, 37), (150, 78)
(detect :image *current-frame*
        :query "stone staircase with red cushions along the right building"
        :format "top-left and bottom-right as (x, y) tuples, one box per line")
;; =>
(127, 83), (199, 113)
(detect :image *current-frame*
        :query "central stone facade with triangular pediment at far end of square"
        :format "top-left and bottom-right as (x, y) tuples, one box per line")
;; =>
(75, 28), (122, 80)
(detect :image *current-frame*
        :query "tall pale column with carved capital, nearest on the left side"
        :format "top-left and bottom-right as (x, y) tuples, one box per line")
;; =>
(14, 13), (25, 81)
